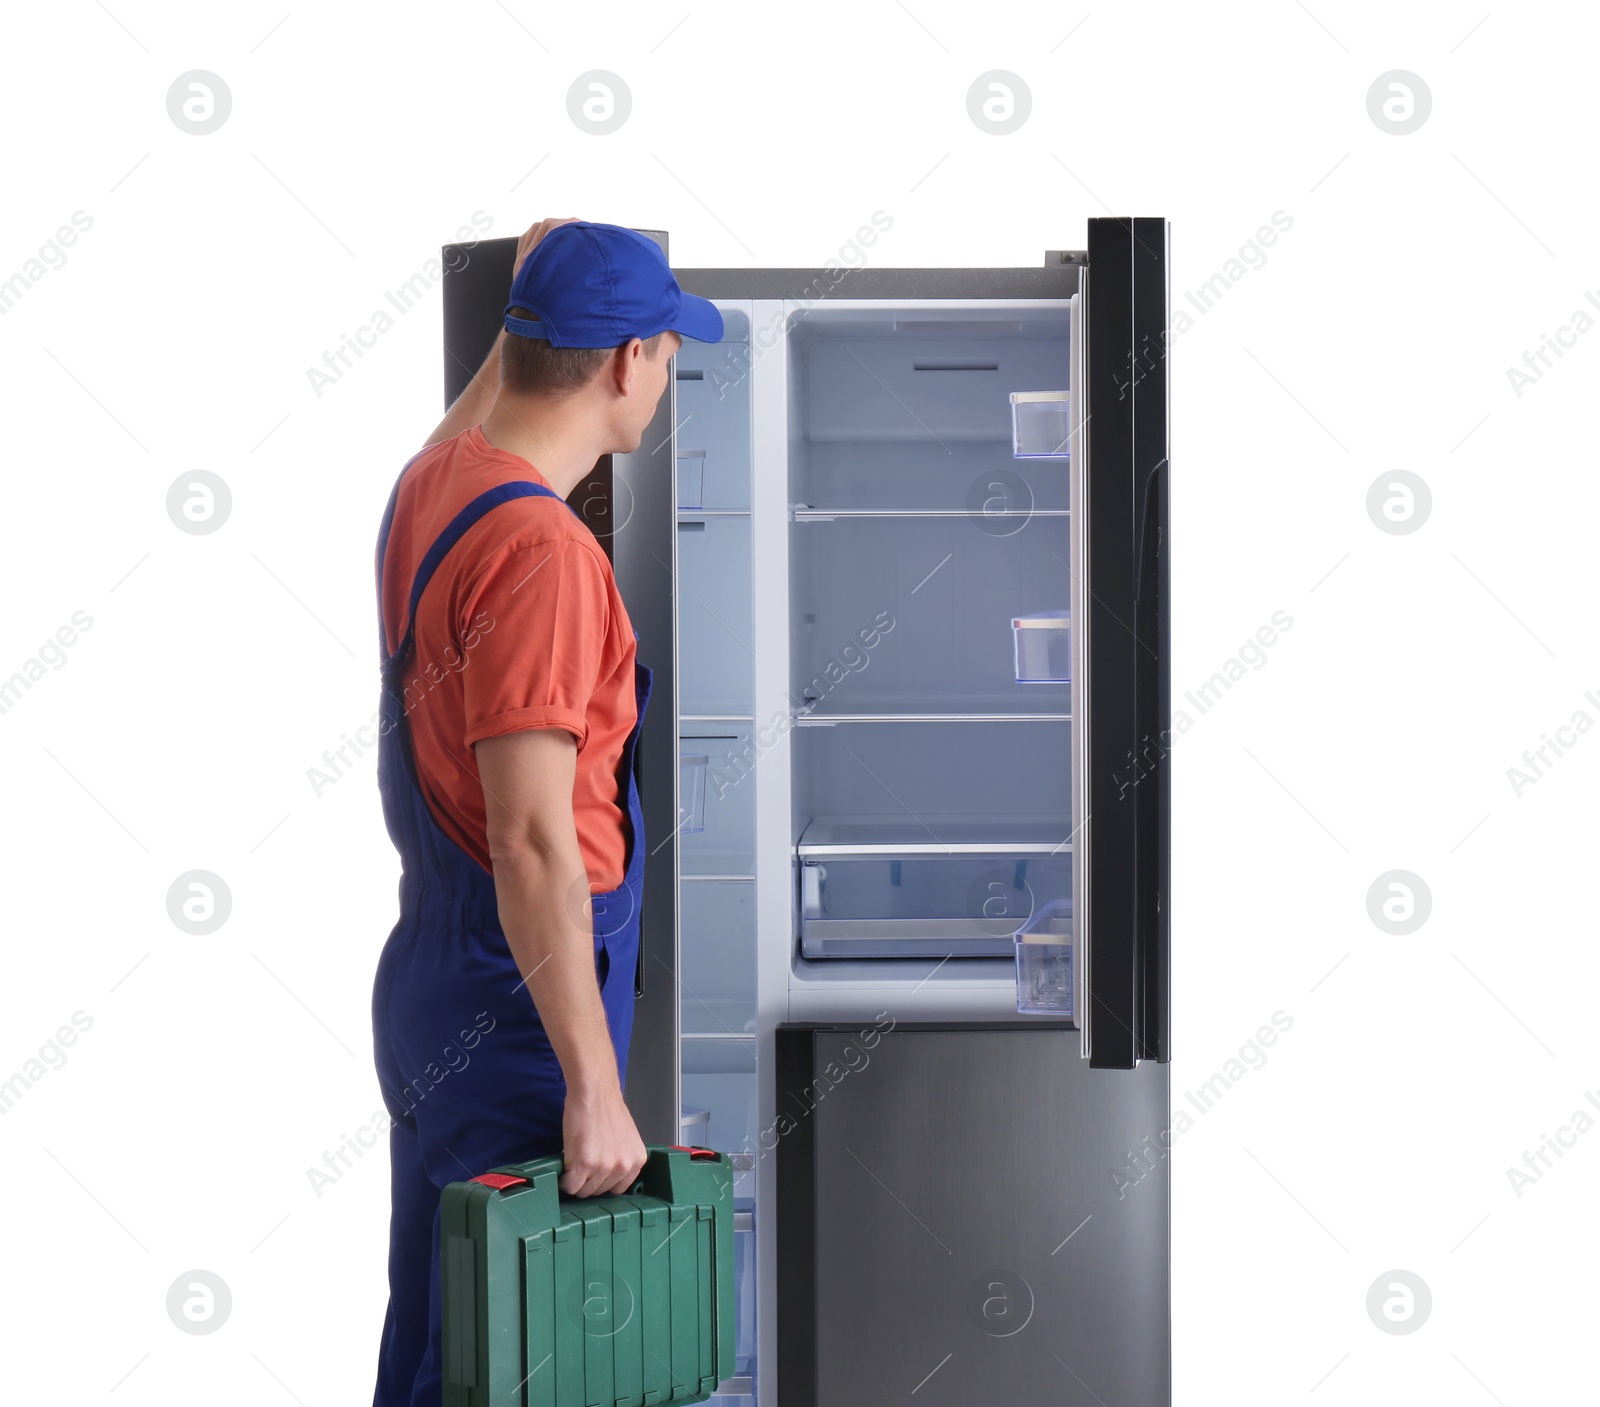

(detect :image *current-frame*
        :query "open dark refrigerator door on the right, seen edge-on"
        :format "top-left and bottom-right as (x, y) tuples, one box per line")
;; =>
(1072, 219), (1171, 1069)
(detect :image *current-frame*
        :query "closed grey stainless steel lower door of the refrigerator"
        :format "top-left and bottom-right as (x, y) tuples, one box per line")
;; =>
(774, 1018), (1171, 1407)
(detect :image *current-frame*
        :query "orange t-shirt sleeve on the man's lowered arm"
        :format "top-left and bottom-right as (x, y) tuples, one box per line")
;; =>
(462, 538), (610, 748)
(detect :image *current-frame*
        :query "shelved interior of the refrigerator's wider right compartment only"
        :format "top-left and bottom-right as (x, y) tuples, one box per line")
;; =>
(787, 299), (1072, 986)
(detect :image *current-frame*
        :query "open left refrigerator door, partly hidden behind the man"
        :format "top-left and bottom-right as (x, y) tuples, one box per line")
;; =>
(442, 229), (680, 1144)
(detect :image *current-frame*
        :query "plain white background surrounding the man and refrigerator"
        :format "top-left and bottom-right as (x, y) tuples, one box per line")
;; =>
(0, 0), (1600, 1407)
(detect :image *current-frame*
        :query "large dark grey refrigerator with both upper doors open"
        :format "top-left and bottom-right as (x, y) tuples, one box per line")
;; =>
(443, 218), (1171, 1407)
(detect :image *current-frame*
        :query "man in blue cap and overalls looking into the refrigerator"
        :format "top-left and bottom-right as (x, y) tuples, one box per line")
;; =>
(373, 219), (722, 1407)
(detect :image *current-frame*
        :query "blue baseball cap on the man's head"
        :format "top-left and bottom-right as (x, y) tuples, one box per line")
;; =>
(506, 219), (722, 347)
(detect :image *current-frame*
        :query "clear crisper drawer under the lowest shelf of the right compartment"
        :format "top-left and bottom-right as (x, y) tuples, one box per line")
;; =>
(800, 848), (1072, 957)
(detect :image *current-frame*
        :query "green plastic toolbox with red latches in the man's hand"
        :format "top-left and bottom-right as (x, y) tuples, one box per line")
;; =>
(438, 1148), (734, 1407)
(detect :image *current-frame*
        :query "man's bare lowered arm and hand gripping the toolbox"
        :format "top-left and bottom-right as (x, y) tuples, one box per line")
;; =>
(475, 728), (645, 1197)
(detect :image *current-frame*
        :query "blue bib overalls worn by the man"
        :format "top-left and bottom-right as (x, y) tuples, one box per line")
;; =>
(373, 466), (650, 1407)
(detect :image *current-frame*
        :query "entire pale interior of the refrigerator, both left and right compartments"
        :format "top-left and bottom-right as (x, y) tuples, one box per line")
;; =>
(665, 291), (1070, 1407)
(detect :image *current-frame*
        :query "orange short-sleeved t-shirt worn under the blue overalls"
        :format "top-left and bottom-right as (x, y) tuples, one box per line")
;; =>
(382, 426), (638, 893)
